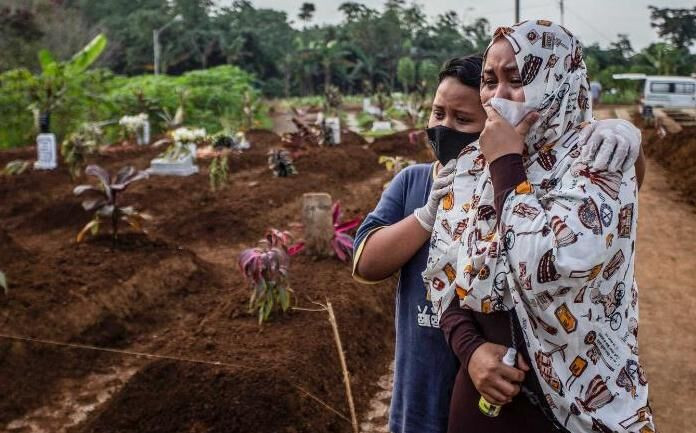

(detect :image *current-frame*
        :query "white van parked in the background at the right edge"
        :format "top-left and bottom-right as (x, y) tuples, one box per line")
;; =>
(613, 74), (696, 108)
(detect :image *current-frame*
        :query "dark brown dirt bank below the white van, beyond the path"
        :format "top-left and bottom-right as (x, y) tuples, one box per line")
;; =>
(639, 121), (696, 205)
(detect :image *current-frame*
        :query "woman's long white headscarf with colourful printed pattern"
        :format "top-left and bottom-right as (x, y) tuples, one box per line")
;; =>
(423, 20), (655, 433)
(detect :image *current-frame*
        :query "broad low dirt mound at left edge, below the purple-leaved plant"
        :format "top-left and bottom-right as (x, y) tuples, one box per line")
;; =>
(0, 235), (220, 424)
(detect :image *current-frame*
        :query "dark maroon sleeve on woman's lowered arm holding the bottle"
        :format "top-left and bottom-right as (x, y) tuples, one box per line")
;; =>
(440, 297), (486, 368)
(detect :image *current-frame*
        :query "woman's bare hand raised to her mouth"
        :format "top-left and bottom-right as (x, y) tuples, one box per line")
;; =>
(479, 105), (539, 164)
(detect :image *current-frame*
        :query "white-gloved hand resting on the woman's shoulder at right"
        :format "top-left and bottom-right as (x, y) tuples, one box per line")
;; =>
(579, 119), (641, 172)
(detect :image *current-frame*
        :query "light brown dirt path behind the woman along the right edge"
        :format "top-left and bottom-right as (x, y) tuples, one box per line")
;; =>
(636, 160), (696, 433)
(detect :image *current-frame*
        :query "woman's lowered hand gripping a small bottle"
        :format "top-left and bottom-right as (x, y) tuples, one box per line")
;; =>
(468, 343), (529, 406)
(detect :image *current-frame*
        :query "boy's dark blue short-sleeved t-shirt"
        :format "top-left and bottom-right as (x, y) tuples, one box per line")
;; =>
(354, 164), (459, 433)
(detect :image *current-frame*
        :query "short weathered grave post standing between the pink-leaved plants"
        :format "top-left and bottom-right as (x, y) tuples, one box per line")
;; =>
(302, 192), (334, 257)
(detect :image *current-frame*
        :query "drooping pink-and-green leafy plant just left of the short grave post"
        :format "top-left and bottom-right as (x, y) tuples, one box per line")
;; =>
(238, 229), (291, 324)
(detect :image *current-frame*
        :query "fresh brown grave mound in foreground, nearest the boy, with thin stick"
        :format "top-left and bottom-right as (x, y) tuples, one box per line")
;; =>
(72, 253), (393, 433)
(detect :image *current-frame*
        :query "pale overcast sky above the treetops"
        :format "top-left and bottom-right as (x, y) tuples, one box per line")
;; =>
(217, 0), (694, 50)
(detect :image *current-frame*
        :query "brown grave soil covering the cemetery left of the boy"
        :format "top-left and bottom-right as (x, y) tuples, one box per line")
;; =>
(0, 131), (394, 433)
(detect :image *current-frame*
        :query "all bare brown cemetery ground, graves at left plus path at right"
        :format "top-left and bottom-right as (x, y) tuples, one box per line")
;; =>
(0, 109), (696, 433)
